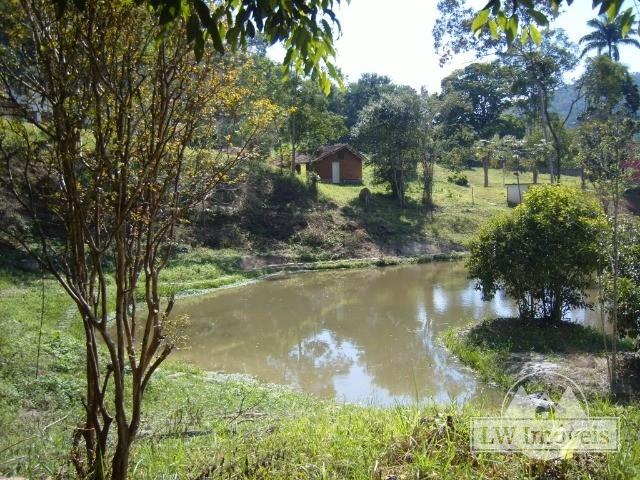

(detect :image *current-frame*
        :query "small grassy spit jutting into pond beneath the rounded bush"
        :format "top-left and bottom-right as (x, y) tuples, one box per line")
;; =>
(441, 318), (640, 399)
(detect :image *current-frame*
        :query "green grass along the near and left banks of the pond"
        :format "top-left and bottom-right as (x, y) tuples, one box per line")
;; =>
(0, 260), (640, 479)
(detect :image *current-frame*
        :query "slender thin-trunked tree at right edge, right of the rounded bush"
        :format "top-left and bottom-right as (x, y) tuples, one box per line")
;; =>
(576, 52), (640, 393)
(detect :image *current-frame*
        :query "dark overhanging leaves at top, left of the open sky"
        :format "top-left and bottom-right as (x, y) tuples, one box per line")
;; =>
(51, 0), (341, 93)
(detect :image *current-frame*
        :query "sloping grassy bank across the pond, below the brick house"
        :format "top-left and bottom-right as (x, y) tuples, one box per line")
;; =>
(199, 167), (579, 261)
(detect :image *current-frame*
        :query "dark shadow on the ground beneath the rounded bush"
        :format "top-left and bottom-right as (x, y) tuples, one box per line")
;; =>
(465, 318), (632, 353)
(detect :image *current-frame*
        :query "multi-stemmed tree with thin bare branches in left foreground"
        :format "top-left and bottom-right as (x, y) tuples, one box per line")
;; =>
(0, 0), (270, 479)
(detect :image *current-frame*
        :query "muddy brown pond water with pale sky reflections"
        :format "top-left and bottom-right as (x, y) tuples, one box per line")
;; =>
(174, 262), (596, 405)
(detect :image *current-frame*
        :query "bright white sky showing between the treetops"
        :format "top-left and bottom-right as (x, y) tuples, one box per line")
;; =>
(270, 0), (640, 92)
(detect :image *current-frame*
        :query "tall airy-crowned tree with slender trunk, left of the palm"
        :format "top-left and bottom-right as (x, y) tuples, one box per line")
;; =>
(433, 0), (584, 181)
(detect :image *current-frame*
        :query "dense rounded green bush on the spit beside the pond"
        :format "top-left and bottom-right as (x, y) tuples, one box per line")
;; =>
(467, 185), (607, 322)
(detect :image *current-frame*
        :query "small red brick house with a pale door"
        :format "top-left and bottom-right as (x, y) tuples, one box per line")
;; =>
(296, 143), (365, 183)
